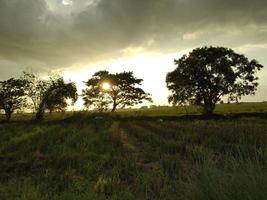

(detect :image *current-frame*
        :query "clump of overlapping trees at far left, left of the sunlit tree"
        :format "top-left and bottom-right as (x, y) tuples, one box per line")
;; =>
(0, 72), (78, 121)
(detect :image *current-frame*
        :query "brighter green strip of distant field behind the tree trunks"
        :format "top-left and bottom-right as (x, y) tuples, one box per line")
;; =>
(0, 102), (267, 121)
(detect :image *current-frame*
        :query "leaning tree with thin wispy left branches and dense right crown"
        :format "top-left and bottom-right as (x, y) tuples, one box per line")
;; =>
(23, 72), (78, 120)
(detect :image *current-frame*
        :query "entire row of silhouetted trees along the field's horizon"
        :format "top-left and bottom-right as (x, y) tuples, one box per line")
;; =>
(0, 46), (263, 121)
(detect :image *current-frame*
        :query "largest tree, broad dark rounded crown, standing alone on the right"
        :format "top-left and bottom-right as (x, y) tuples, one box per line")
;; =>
(166, 47), (263, 115)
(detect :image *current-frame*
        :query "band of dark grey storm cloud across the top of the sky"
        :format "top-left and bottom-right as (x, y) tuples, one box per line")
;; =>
(0, 0), (267, 76)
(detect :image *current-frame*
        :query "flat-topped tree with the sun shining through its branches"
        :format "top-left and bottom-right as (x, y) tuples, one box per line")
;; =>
(83, 71), (152, 112)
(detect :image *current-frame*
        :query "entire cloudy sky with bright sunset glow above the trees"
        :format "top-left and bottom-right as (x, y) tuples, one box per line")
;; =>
(0, 0), (267, 108)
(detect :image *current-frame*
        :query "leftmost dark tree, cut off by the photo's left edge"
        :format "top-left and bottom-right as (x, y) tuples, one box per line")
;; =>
(0, 78), (27, 121)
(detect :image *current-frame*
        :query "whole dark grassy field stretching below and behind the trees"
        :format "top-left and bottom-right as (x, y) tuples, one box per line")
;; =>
(0, 103), (267, 200)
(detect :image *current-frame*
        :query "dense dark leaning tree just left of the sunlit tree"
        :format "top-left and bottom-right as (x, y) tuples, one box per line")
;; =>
(36, 76), (78, 120)
